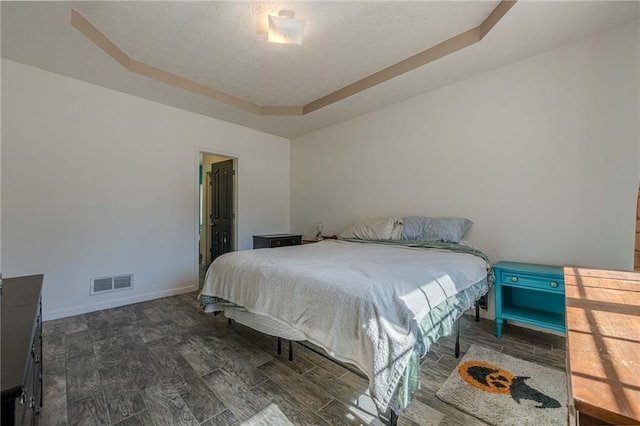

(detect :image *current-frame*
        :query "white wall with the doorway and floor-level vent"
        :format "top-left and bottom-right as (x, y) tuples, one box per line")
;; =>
(1, 60), (289, 319)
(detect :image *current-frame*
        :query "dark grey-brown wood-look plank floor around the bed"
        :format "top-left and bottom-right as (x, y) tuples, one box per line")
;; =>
(42, 293), (565, 426)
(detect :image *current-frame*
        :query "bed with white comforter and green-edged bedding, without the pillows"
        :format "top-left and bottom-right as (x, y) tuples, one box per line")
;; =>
(201, 218), (493, 424)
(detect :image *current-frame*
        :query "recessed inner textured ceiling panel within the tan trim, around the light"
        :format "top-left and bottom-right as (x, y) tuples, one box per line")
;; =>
(74, 1), (498, 105)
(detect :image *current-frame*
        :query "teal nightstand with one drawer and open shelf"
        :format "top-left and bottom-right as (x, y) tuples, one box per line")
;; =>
(493, 262), (565, 338)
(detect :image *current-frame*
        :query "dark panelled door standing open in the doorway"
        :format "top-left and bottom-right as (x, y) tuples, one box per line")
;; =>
(209, 160), (234, 262)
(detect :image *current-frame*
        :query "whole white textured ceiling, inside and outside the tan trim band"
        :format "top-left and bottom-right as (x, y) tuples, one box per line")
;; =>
(1, 1), (640, 137)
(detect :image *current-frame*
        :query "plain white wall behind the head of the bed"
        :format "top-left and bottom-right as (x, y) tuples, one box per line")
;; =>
(291, 22), (640, 269)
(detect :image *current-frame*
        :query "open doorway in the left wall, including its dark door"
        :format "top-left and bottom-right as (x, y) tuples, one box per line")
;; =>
(198, 152), (237, 289)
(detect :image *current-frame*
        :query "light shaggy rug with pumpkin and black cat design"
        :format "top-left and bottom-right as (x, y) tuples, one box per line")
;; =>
(436, 345), (567, 426)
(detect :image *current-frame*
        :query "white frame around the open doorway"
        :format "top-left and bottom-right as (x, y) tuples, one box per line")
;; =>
(193, 146), (240, 289)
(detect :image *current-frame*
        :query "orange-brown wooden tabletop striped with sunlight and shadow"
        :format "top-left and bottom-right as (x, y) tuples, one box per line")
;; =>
(564, 266), (640, 425)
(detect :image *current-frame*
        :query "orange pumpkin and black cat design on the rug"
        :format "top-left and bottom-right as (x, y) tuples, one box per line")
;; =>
(458, 361), (560, 408)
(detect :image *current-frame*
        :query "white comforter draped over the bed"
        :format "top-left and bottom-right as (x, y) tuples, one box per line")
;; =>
(202, 240), (487, 412)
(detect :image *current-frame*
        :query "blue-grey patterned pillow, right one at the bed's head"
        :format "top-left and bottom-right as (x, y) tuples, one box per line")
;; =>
(402, 216), (473, 243)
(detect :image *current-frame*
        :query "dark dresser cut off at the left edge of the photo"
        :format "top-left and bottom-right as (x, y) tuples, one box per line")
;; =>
(1, 275), (44, 426)
